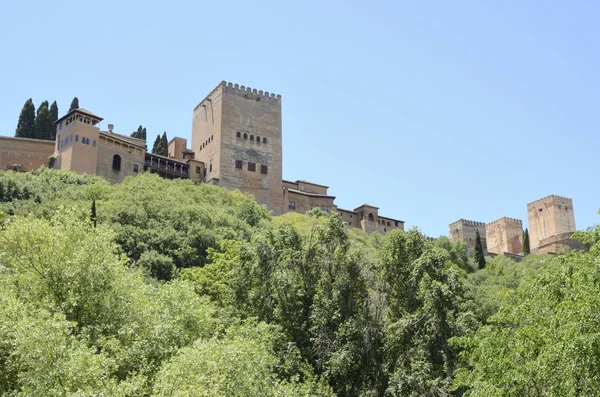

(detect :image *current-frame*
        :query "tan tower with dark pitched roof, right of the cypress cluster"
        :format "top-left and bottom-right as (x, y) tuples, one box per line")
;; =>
(52, 108), (102, 175)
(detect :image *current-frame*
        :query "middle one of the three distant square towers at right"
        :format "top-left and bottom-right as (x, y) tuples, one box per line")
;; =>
(485, 217), (523, 255)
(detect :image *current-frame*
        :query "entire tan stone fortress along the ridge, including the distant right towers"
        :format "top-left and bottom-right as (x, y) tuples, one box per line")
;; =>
(0, 81), (580, 257)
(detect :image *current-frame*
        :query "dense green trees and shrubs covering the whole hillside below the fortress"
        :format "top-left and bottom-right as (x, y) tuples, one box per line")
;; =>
(0, 169), (600, 396)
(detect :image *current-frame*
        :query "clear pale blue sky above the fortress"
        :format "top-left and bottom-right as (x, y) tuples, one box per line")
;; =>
(0, 0), (600, 236)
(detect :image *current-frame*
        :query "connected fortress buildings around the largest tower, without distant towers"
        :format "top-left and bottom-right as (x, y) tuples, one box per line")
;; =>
(0, 81), (404, 233)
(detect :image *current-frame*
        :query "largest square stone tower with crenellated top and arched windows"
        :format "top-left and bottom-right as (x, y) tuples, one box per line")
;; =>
(191, 81), (284, 215)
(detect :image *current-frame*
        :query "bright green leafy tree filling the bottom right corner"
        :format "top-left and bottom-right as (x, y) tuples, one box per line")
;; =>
(454, 232), (600, 397)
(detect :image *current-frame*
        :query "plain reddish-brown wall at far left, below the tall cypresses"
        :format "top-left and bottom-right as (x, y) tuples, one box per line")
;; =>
(0, 136), (55, 171)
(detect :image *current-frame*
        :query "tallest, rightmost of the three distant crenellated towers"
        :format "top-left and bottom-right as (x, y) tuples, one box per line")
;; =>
(527, 195), (575, 252)
